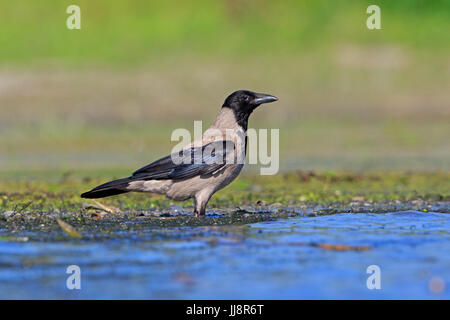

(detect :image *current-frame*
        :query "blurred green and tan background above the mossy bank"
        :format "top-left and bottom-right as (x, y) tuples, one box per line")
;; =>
(0, 0), (450, 173)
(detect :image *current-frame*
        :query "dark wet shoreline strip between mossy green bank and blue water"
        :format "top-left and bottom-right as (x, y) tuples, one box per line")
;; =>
(0, 201), (450, 241)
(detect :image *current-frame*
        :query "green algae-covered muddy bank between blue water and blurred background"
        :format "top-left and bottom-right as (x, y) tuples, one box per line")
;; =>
(0, 171), (450, 241)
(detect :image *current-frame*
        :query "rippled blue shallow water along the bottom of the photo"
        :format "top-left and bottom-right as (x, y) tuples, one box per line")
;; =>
(0, 211), (450, 299)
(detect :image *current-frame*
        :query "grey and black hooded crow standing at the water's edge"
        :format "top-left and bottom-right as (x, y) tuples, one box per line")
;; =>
(81, 90), (278, 216)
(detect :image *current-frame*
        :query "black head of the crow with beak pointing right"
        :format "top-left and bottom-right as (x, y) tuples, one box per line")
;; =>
(222, 90), (278, 130)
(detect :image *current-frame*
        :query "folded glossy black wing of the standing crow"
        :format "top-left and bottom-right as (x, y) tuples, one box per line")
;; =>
(131, 140), (235, 180)
